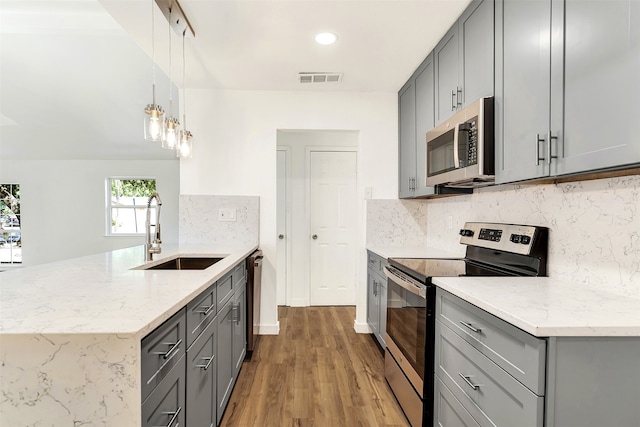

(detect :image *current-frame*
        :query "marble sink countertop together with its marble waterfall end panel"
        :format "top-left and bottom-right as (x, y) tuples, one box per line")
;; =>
(0, 244), (257, 426)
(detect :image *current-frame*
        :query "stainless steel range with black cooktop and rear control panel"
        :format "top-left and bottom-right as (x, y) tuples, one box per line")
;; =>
(385, 222), (548, 427)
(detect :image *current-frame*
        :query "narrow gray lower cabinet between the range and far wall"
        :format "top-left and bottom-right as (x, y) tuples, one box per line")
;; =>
(367, 251), (387, 348)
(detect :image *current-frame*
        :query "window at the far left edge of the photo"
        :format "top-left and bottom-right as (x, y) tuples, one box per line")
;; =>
(0, 184), (22, 265)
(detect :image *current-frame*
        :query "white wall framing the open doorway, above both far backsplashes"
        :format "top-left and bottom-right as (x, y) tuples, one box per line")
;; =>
(180, 90), (398, 333)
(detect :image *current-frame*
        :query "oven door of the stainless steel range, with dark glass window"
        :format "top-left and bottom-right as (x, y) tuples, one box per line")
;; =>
(385, 265), (428, 397)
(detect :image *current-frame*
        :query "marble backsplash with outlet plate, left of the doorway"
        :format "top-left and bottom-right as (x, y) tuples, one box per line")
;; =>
(179, 195), (260, 248)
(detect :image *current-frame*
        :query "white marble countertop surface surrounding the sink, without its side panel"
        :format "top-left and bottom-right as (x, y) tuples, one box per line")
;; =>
(0, 244), (257, 338)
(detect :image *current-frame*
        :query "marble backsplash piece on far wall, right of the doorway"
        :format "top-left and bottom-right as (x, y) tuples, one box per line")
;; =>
(367, 200), (427, 246)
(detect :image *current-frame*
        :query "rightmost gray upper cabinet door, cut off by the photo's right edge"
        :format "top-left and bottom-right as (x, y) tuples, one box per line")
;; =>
(551, 0), (640, 175)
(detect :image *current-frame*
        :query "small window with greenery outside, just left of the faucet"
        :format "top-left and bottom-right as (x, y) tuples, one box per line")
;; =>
(107, 178), (156, 236)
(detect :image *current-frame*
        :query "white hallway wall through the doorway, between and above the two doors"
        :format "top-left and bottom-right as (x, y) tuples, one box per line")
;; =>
(277, 130), (359, 306)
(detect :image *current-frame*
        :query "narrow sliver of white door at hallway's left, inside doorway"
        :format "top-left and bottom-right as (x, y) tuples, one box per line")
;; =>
(276, 150), (289, 305)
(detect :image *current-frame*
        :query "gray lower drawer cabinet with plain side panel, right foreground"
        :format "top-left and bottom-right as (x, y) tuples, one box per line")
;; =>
(434, 288), (640, 427)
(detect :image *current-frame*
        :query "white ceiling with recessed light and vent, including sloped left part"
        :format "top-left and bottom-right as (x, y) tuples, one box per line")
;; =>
(0, 0), (470, 159)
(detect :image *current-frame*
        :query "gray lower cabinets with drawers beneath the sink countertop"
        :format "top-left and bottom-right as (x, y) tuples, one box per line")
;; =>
(141, 260), (247, 427)
